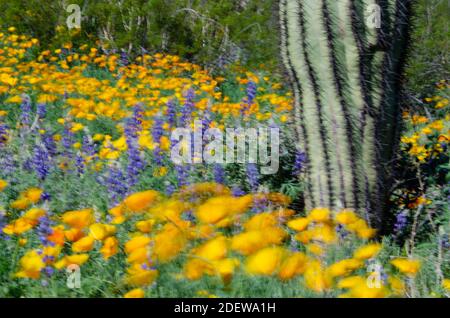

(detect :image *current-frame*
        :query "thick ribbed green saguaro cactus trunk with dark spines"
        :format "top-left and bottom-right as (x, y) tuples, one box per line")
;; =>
(278, 0), (412, 227)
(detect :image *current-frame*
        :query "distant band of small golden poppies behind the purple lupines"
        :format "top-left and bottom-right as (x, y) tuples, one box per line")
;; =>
(0, 30), (292, 166)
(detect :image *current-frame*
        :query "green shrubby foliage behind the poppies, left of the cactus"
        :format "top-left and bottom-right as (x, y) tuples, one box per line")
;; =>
(0, 0), (276, 68)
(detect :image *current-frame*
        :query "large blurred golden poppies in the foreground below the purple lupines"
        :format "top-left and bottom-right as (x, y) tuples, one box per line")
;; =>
(3, 183), (440, 297)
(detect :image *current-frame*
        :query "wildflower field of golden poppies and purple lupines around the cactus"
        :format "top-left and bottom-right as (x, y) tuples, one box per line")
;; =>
(0, 4), (450, 298)
